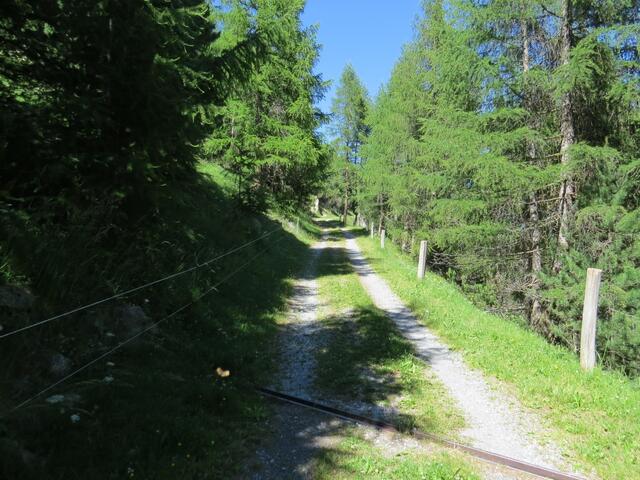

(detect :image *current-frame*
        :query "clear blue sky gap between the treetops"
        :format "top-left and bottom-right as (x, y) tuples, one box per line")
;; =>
(302, 0), (422, 112)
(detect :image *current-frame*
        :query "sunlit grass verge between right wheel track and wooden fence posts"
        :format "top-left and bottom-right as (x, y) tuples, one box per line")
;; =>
(358, 231), (640, 479)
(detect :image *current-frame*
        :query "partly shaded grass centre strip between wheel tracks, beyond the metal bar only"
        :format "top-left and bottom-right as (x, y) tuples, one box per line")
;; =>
(316, 221), (464, 436)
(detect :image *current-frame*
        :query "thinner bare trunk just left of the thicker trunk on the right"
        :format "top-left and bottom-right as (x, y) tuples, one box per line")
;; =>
(520, 9), (545, 330)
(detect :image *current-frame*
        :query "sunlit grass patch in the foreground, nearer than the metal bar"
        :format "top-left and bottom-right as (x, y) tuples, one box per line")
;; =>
(314, 431), (480, 480)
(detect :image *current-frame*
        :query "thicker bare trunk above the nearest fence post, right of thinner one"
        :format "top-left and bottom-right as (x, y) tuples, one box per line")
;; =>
(554, 0), (576, 271)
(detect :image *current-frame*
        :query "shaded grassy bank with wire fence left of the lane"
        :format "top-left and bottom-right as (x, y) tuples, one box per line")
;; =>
(0, 165), (317, 480)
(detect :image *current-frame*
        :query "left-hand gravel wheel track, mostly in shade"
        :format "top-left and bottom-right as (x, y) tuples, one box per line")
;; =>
(249, 228), (418, 480)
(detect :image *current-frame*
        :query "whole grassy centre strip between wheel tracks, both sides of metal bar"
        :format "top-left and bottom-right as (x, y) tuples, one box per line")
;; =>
(308, 222), (477, 480)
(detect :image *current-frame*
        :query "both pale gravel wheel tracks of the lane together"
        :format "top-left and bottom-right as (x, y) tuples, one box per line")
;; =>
(246, 229), (584, 480)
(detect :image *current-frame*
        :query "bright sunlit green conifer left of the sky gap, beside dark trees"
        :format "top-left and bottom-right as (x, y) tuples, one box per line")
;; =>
(205, 0), (327, 210)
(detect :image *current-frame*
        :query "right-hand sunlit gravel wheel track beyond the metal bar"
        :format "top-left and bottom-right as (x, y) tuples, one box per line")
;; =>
(344, 231), (571, 471)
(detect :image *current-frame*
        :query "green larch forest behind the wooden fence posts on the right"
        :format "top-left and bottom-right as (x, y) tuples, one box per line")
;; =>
(325, 0), (640, 376)
